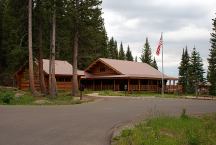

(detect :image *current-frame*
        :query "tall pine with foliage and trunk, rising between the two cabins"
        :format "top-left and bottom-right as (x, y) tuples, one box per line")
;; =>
(65, 0), (106, 95)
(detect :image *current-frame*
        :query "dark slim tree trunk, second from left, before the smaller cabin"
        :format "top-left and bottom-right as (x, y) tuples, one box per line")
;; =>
(38, 16), (46, 94)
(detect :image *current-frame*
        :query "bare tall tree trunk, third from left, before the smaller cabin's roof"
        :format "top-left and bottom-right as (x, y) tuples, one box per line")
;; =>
(49, 4), (56, 98)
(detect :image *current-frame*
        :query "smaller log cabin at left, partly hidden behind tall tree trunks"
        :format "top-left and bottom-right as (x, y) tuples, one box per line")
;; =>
(14, 59), (84, 90)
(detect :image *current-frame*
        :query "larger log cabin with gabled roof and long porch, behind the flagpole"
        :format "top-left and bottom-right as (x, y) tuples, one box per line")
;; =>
(82, 58), (181, 92)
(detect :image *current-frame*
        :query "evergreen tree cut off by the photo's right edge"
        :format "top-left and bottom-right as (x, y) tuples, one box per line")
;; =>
(208, 15), (216, 96)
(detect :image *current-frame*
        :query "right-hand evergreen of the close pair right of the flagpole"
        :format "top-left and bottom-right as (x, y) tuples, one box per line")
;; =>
(189, 47), (204, 93)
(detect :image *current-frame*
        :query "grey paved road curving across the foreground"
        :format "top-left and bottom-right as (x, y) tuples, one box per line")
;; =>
(0, 98), (216, 145)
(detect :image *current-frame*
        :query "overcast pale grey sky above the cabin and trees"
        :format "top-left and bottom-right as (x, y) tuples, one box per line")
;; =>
(102, 0), (216, 76)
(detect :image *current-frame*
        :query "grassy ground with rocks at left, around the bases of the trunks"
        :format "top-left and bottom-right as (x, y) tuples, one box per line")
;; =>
(0, 87), (91, 105)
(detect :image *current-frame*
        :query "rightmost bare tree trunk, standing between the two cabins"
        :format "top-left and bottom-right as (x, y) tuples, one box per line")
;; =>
(72, 31), (79, 96)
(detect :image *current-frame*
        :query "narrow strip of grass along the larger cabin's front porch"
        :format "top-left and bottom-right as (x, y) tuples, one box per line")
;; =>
(97, 90), (183, 98)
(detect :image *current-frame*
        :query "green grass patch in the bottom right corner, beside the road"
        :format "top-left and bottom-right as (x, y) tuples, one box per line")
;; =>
(113, 114), (216, 145)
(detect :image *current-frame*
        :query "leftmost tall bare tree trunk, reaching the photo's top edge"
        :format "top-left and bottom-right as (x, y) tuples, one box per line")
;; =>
(28, 0), (36, 95)
